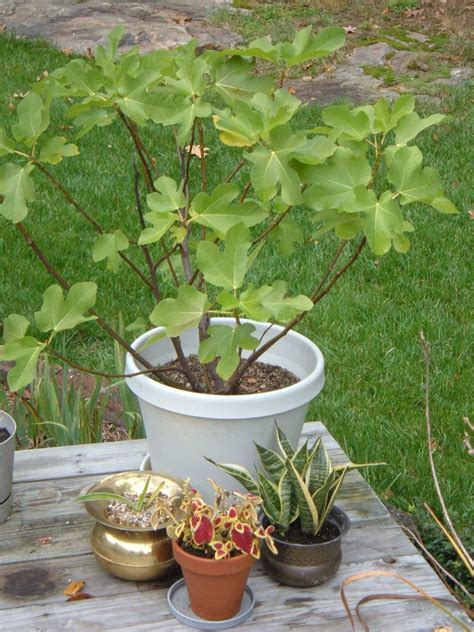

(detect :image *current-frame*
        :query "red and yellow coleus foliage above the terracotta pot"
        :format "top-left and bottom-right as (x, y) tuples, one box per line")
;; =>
(158, 480), (277, 560)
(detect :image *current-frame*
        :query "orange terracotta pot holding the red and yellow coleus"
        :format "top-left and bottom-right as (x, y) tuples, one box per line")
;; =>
(173, 540), (255, 621)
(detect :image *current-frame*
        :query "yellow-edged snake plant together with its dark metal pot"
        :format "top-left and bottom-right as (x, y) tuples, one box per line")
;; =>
(211, 426), (380, 587)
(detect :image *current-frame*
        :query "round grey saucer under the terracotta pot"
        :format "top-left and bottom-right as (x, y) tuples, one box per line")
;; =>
(168, 579), (255, 630)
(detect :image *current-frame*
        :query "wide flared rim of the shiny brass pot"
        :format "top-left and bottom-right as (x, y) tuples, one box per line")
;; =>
(81, 470), (183, 533)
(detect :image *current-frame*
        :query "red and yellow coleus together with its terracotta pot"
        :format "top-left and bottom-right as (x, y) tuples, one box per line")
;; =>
(160, 480), (277, 621)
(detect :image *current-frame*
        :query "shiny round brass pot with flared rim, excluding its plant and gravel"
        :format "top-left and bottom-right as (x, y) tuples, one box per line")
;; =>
(84, 471), (182, 581)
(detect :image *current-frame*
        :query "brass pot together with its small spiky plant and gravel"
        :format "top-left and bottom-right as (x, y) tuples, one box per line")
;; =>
(77, 471), (182, 581)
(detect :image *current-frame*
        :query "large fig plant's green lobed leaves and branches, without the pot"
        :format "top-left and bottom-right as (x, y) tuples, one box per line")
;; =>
(0, 27), (456, 394)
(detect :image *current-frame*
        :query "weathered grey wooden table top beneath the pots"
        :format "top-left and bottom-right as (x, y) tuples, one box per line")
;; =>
(0, 422), (466, 632)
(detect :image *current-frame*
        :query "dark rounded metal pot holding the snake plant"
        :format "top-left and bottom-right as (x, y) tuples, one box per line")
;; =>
(261, 507), (350, 588)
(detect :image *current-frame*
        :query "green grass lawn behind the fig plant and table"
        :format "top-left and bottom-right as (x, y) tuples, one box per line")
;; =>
(0, 35), (474, 552)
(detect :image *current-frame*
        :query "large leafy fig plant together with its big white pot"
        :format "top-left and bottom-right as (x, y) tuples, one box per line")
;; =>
(0, 27), (456, 486)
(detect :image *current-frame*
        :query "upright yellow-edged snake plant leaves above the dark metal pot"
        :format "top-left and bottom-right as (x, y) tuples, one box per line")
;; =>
(207, 425), (382, 535)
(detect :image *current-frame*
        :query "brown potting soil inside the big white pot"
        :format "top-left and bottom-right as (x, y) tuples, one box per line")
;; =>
(161, 355), (300, 395)
